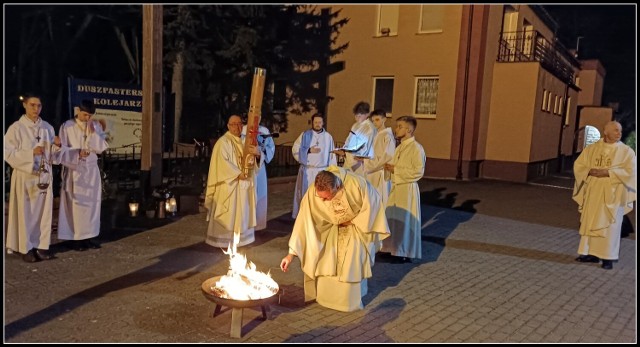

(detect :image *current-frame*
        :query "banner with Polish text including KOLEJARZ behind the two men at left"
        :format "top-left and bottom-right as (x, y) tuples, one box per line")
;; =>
(69, 77), (142, 153)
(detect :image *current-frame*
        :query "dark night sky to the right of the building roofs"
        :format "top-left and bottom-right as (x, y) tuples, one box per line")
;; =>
(544, 4), (637, 128)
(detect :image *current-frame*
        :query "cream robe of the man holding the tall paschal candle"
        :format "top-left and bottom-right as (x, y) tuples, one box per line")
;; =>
(205, 131), (258, 248)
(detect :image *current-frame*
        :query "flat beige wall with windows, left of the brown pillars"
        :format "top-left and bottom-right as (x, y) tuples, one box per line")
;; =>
(316, 5), (462, 158)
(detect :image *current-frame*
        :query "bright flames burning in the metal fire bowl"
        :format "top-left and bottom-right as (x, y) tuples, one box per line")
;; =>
(211, 244), (278, 300)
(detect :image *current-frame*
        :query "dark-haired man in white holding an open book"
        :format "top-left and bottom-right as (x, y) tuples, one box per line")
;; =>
(334, 101), (378, 177)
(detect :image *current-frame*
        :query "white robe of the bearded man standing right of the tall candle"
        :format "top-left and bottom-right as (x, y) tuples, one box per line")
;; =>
(291, 129), (337, 219)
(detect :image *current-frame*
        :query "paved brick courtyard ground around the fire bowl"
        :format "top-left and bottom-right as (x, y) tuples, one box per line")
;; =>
(4, 178), (637, 343)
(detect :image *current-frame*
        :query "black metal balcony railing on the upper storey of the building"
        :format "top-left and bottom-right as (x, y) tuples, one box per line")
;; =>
(497, 30), (578, 84)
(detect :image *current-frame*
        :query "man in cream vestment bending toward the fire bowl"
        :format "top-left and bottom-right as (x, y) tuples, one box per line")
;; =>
(280, 166), (389, 312)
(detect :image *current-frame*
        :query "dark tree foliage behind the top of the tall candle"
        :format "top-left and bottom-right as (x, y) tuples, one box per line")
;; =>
(164, 5), (348, 138)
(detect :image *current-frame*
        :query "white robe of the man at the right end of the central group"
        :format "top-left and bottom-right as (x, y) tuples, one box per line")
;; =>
(382, 137), (427, 259)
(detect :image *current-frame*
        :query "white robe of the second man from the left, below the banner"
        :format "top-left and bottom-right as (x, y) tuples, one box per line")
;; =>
(58, 119), (109, 240)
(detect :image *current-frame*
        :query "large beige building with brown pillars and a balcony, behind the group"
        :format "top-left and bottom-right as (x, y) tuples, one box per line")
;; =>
(279, 4), (602, 182)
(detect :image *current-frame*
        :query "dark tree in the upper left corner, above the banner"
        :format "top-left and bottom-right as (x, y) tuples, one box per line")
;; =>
(5, 5), (140, 126)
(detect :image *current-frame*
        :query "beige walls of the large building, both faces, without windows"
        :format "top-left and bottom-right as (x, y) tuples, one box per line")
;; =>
(277, 4), (578, 184)
